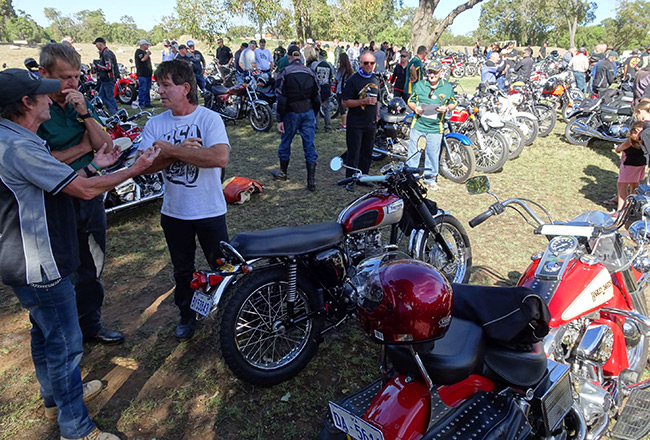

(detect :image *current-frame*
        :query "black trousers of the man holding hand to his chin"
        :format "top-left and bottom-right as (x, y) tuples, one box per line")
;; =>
(70, 195), (106, 339)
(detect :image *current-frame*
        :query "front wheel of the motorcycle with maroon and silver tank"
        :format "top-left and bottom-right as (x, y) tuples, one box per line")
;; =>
(411, 213), (472, 283)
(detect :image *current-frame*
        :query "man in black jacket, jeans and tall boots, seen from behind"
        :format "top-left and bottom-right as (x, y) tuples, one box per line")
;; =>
(271, 44), (320, 191)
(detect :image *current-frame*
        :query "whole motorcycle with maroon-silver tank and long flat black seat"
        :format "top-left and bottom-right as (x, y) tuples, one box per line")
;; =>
(191, 158), (472, 386)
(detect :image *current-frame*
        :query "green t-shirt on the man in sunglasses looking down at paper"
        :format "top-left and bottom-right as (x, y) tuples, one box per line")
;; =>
(409, 79), (456, 133)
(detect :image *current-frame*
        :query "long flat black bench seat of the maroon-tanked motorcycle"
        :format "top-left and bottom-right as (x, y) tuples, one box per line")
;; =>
(230, 222), (344, 259)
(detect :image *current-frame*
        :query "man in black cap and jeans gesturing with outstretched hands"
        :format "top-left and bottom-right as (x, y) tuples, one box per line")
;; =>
(0, 69), (158, 440)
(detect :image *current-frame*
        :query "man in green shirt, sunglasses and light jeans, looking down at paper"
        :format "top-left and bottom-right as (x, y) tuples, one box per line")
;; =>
(407, 60), (456, 191)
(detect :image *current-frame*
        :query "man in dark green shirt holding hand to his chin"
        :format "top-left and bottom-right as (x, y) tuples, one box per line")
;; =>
(38, 43), (124, 344)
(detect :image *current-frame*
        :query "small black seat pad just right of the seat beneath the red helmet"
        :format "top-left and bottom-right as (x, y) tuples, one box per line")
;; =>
(483, 342), (546, 387)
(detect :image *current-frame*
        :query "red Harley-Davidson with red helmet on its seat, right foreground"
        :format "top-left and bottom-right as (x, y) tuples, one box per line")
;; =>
(319, 176), (650, 440)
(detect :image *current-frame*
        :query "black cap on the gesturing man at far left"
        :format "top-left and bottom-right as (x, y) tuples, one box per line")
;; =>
(0, 69), (61, 106)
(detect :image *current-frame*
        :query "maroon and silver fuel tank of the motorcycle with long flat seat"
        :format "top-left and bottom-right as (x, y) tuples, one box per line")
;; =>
(337, 190), (404, 234)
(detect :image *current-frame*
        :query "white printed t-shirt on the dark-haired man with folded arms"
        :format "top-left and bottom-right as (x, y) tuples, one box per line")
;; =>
(139, 106), (230, 220)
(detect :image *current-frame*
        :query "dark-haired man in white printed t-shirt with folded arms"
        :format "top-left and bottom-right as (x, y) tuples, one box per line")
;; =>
(140, 60), (230, 340)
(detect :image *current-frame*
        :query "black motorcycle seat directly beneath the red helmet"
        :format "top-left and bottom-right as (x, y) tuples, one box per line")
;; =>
(387, 318), (485, 385)
